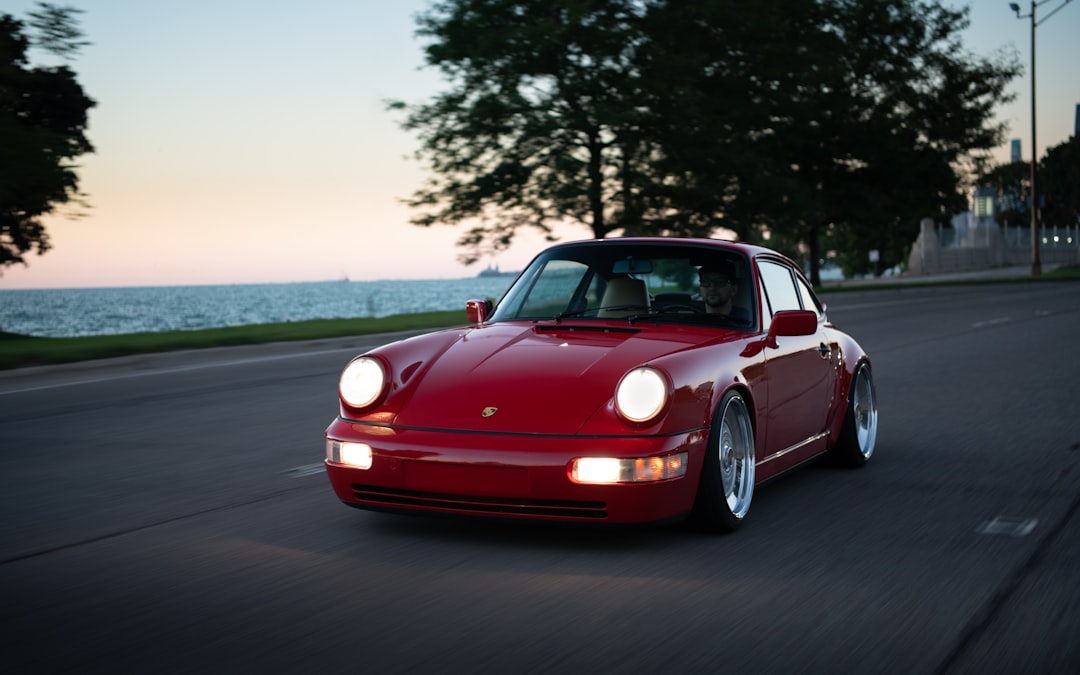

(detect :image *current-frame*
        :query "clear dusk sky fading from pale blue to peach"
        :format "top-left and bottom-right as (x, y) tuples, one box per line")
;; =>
(0, 0), (1080, 289)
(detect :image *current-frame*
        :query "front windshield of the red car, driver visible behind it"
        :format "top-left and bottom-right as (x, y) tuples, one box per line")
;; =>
(491, 241), (755, 327)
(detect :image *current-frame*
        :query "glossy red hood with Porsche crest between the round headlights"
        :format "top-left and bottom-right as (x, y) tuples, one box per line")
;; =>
(383, 324), (717, 434)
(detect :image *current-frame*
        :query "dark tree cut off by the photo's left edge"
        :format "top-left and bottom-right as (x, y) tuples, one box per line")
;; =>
(0, 3), (95, 272)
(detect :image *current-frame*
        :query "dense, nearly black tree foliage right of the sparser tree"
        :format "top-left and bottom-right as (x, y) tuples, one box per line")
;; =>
(648, 0), (1017, 283)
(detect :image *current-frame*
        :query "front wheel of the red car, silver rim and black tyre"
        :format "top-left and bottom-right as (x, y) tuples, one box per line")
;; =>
(693, 391), (755, 532)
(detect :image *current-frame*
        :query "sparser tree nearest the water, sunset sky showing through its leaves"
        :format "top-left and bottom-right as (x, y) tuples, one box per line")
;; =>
(391, 0), (647, 262)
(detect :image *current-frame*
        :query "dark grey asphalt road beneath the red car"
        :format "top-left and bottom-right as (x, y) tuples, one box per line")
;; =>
(0, 283), (1080, 674)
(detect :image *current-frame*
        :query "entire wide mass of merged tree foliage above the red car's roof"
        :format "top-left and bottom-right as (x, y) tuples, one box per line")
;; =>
(393, 0), (1018, 282)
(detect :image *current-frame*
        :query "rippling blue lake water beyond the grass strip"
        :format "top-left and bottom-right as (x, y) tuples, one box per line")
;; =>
(0, 275), (514, 337)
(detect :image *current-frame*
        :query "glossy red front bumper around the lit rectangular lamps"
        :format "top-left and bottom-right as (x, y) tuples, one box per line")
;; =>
(326, 418), (708, 524)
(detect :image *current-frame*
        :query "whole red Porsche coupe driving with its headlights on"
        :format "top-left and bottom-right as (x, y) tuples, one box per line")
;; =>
(326, 238), (877, 531)
